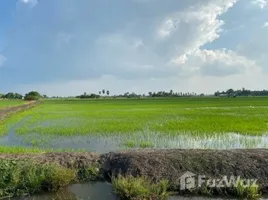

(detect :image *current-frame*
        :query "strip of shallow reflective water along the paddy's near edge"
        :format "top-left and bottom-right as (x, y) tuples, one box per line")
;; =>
(0, 121), (268, 153)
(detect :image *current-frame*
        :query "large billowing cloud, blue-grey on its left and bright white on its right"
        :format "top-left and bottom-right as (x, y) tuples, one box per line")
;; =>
(89, 0), (250, 79)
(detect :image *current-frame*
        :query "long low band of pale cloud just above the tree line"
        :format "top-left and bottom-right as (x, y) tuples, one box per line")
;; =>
(16, 72), (268, 96)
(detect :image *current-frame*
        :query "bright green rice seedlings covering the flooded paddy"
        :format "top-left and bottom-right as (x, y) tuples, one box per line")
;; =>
(0, 97), (268, 148)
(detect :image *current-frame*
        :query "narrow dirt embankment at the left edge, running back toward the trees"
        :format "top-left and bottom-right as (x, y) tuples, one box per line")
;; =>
(0, 101), (39, 121)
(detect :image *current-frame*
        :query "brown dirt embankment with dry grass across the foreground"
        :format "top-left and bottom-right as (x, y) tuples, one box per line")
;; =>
(0, 149), (268, 193)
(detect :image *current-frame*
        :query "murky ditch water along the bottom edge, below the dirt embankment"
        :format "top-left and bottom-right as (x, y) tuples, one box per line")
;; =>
(12, 182), (267, 200)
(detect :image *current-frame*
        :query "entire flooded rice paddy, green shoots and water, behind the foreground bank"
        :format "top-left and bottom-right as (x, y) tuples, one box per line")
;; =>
(0, 97), (268, 153)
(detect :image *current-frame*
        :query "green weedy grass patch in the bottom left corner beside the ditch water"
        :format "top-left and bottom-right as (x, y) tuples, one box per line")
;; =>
(0, 160), (76, 197)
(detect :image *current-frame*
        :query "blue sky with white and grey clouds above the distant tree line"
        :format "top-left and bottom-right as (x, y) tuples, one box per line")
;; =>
(0, 0), (268, 96)
